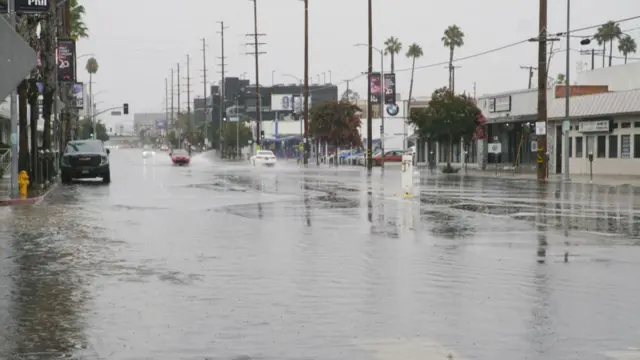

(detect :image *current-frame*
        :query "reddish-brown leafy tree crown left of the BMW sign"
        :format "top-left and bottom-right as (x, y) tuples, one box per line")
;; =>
(309, 101), (362, 147)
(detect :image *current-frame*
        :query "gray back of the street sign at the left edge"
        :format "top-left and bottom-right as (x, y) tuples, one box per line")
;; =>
(0, 16), (38, 99)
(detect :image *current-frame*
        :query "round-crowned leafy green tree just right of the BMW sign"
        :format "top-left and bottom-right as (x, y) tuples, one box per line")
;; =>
(409, 88), (482, 169)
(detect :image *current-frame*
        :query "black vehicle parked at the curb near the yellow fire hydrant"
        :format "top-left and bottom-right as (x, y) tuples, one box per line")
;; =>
(60, 139), (111, 184)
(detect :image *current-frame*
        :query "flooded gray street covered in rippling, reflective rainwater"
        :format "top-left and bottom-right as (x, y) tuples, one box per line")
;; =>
(0, 150), (640, 360)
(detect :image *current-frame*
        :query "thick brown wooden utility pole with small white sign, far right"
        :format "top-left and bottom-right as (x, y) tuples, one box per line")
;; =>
(535, 0), (549, 182)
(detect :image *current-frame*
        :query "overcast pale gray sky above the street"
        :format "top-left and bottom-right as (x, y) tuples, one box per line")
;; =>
(78, 0), (640, 129)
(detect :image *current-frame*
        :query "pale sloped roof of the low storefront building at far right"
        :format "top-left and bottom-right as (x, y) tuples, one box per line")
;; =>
(548, 89), (640, 119)
